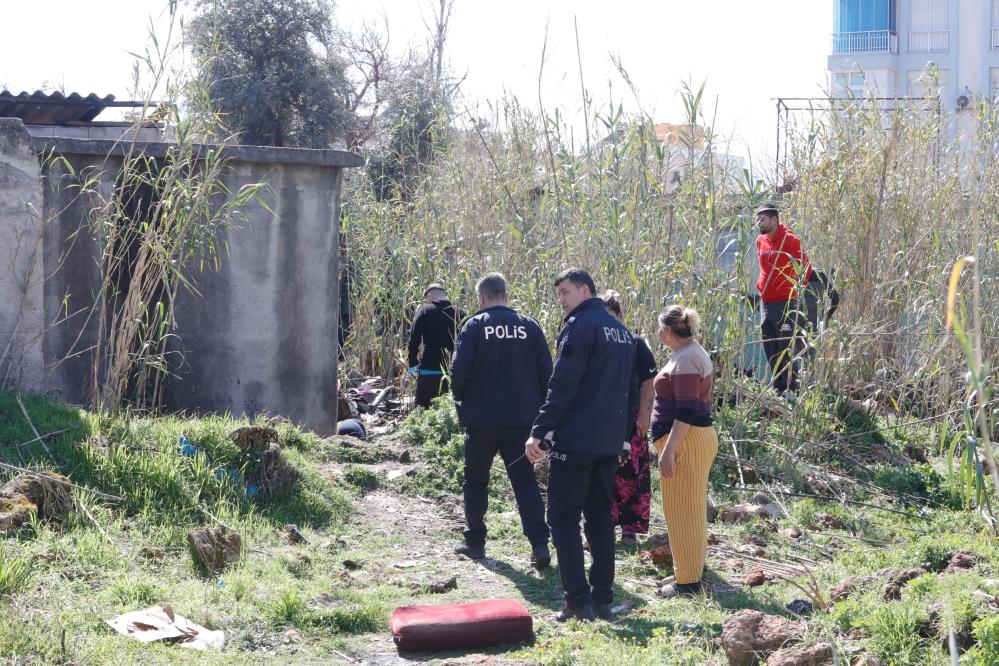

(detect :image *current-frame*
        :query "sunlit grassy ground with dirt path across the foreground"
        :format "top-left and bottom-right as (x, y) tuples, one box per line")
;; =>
(0, 386), (999, 665)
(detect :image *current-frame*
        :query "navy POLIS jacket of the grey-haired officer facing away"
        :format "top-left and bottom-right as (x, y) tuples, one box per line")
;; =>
(451, 305), (552, 429)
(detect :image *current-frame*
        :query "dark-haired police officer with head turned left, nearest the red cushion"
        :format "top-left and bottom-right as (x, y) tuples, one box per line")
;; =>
(524, 268), (639, 621)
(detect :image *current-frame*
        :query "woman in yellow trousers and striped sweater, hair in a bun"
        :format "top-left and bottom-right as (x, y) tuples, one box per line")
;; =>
(652, 305), (718, 597)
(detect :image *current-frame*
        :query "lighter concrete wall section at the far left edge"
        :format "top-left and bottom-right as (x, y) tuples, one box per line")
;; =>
(0, 118), (44, 391)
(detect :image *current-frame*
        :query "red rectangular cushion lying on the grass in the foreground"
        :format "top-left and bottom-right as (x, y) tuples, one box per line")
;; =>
(389, 599), (534, 652)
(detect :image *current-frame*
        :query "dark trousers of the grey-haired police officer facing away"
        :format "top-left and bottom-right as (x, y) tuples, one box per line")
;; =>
(463, 426), (548, 548)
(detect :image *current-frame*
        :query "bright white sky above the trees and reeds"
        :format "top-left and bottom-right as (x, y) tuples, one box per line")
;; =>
(0, 0), (833, 171)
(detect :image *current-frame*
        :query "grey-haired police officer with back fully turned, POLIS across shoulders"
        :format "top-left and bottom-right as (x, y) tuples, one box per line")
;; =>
(451, 273), (552, 569)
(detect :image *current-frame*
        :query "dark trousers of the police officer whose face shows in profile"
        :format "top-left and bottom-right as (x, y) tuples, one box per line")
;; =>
(548, 449), (617, 608)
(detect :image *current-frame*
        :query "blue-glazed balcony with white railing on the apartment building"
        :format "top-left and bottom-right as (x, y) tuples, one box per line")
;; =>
(832, 0), (898, 54)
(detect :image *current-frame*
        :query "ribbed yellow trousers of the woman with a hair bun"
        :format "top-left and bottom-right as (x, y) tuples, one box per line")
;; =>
(655, 426), (718, 583)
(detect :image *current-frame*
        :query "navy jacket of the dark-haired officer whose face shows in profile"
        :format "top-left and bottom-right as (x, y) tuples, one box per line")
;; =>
(531, 298), (638, 455)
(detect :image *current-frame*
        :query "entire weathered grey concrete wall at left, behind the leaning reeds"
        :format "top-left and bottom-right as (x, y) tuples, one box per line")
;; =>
(0, 121), (361, 434)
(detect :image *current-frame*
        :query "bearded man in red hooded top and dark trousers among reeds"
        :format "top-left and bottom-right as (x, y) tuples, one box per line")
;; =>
(756, 204), (812, 393)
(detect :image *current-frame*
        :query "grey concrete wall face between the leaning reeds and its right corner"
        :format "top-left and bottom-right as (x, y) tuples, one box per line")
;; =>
(166, 162), (340, 433)
